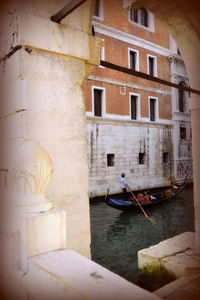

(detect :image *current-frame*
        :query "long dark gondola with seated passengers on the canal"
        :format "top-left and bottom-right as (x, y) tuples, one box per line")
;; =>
(105, 179), (186, 210)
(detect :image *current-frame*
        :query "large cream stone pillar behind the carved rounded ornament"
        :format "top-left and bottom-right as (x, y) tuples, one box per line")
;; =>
(0, 0), (103, 268)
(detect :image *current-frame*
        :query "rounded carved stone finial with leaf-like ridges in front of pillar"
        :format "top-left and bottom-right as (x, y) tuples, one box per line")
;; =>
(9, 142), (53, 212)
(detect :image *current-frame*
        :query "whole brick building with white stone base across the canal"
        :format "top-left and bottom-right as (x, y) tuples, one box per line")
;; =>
(84, 0), (191, 197)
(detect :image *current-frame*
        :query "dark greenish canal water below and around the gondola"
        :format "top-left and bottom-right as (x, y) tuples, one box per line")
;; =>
(90, 187), (194, 284)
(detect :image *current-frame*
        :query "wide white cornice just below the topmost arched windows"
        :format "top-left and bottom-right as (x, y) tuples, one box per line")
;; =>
(92, 21), (171, 56)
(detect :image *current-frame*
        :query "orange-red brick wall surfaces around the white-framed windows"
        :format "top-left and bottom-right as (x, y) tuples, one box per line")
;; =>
(84, 0), (172, 120)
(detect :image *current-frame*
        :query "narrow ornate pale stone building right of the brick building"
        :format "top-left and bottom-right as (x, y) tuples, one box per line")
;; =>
(169, 37), (193, 182)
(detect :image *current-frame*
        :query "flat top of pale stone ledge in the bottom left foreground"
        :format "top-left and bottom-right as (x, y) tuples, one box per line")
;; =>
(21, 250), (159, 300)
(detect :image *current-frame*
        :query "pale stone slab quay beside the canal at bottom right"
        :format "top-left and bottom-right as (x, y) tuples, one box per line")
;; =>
(138, 232), (200, 300)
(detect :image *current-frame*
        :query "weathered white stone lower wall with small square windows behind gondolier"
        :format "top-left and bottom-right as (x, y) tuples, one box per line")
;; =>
(87, 117), (172, 198)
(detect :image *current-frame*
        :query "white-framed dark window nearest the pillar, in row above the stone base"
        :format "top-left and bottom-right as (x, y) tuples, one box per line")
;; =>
(92, 86), (105, 117)
